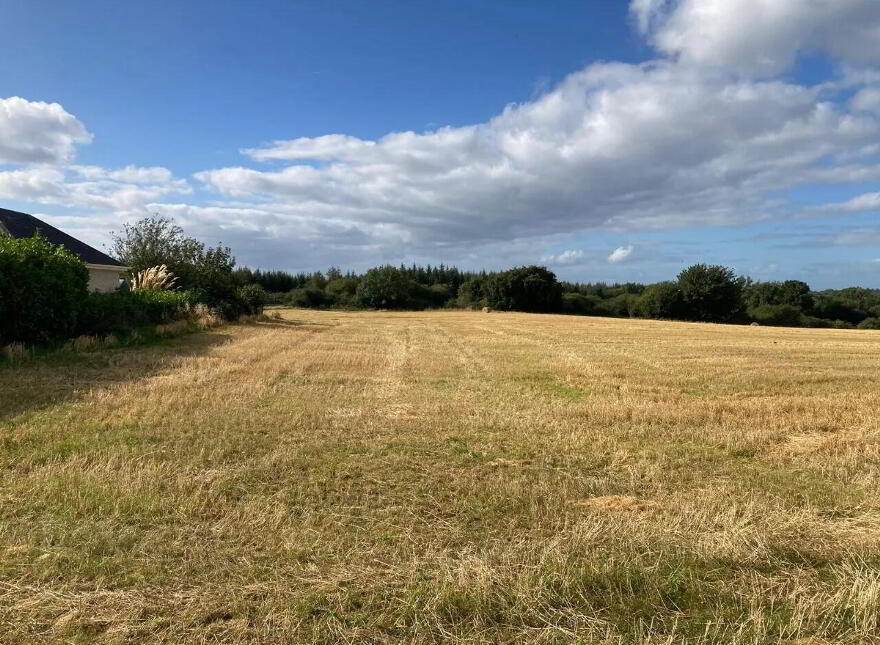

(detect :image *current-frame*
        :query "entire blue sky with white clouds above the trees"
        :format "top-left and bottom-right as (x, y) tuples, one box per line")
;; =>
(0, 0), (880, 289)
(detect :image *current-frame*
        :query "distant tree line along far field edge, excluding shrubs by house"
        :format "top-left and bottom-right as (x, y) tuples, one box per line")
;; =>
(234, 264), (880, 329)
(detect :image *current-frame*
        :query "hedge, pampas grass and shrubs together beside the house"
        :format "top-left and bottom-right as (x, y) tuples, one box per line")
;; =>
(0, 218), (266, 355)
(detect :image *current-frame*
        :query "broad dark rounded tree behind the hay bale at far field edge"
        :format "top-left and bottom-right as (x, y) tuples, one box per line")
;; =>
(485, 266), (562, 313)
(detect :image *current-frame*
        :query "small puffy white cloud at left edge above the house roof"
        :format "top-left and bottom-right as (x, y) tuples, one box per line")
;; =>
(0, 96), (92, 164)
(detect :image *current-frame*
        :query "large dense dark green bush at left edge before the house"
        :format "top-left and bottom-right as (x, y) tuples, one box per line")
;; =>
(0, 235), (89, 345)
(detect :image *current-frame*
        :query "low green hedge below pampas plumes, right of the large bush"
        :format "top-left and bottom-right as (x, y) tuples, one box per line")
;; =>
(77, 289), (197, 335)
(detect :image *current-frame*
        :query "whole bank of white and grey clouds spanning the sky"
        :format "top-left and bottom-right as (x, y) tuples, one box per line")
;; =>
(0, 0), (880, 266)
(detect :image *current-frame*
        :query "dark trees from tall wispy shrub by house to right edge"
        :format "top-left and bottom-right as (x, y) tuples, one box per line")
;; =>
(99, 216), (880, 329)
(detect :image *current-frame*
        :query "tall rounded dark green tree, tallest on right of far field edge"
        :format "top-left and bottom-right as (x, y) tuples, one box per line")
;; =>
(678, 264), (743, 322)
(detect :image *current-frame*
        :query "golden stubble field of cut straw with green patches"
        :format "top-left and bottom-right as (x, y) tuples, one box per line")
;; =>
(0, 310), (880, 645)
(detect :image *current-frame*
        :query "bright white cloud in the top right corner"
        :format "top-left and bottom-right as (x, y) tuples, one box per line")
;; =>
(630, 0), (880, 76)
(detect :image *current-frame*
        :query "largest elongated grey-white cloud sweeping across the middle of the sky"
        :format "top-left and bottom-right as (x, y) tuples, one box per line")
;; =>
(196, 61), (880, 253)
